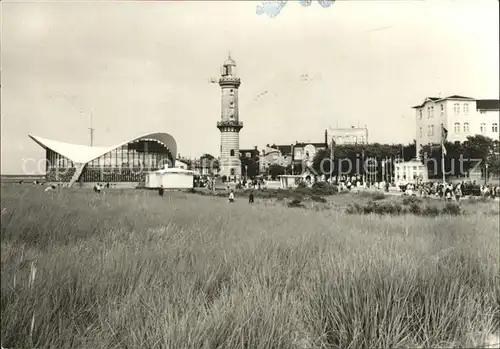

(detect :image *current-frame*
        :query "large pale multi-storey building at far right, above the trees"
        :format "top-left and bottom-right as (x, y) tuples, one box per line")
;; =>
(413, 95), (499, 157)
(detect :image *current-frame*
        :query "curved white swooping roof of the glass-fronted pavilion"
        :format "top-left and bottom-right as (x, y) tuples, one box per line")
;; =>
(29, 133), (177, 163)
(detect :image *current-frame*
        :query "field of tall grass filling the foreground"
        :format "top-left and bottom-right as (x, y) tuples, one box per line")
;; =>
(1, 185), (500, 349)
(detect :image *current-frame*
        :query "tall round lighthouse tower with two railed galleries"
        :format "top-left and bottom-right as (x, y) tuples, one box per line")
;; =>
(217, 54), (243, 179)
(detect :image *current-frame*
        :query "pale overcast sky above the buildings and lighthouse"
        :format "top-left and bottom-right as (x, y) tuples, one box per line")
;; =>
(0, 0), (500, 174)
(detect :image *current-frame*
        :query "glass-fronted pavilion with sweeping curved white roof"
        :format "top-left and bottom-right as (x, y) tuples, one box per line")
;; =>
(29, 133), (177, 186)
